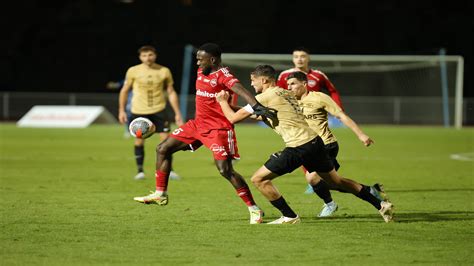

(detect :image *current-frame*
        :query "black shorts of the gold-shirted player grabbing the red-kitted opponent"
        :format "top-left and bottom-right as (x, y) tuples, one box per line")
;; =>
(264, 136), (334, 175)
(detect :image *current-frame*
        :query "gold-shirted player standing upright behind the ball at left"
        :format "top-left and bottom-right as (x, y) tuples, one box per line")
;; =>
(118, 45), (183, 179)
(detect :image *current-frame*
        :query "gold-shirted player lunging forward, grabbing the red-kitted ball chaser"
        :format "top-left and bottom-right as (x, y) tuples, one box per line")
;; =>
(217, 65), (393, 224)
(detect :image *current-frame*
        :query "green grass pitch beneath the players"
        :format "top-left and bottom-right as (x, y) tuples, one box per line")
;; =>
(0, 124), (474, 265)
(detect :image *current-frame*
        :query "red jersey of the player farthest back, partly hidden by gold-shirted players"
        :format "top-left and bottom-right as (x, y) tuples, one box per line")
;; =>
(277, 68), (342, 108)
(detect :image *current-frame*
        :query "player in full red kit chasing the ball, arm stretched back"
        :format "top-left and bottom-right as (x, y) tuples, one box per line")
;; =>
(134, 43), (276, 224)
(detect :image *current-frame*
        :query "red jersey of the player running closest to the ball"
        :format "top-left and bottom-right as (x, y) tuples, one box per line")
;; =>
(195, 67), (240, 131)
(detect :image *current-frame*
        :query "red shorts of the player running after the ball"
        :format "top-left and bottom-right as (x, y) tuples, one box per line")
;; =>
(170, 120), (240, 160)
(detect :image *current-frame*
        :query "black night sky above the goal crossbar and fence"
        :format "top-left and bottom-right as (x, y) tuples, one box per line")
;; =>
(0, 0), (474, 97)
